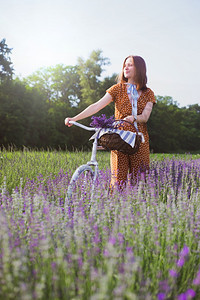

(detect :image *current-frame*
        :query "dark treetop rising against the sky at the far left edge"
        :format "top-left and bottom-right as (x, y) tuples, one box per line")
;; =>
(0, 39), (14, 82)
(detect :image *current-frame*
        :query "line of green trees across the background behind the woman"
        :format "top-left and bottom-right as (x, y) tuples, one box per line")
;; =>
(0, 39), (200, 153)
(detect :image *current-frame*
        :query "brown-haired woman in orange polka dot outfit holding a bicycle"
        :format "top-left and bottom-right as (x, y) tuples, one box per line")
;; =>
(65, 56), (155, 187)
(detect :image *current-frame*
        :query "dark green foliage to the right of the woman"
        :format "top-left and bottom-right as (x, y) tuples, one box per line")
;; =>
(148, 96), (200, 153)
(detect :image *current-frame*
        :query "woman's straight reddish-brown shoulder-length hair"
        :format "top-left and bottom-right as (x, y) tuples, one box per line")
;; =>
(118, 55), (147, 91)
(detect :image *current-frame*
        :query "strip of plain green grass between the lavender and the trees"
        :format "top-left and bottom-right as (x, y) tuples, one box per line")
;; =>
(0, 148), (200, 191)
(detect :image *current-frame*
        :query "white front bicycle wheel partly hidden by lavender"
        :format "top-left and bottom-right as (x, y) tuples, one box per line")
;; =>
(67, 165), (95, 200)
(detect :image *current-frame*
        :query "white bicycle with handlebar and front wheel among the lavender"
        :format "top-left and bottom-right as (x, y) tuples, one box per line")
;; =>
(67, 121), (102, 200)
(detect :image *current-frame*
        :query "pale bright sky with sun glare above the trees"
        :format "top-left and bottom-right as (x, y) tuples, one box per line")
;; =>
(0, 0), (200, 107)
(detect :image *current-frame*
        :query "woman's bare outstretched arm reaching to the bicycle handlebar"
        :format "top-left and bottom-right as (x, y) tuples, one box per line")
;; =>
(65, 93), (112, 127)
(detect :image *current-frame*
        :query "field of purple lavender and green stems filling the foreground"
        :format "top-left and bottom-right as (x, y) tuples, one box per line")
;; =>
(0, 151), (200, 300)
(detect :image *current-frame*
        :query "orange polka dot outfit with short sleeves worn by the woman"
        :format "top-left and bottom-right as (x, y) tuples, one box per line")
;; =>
(107, 83), (155, 185)
